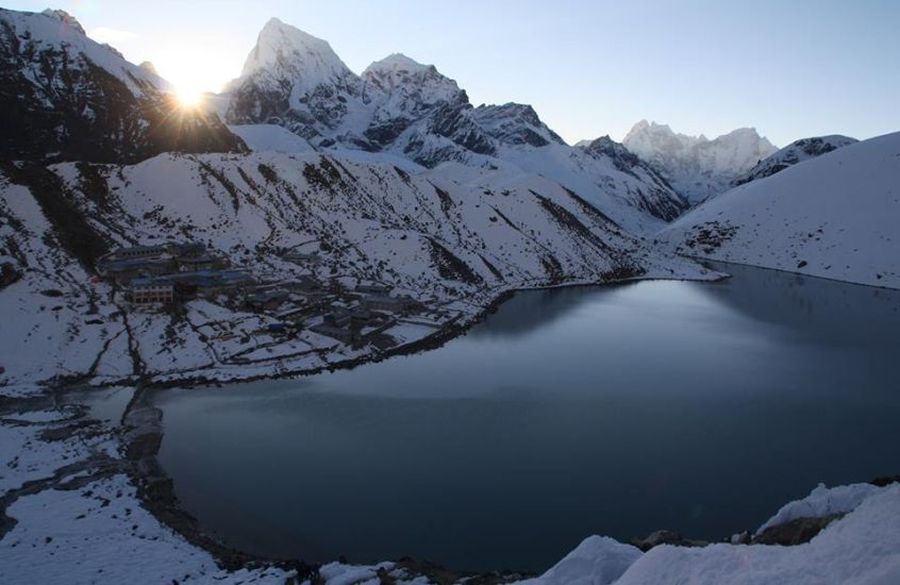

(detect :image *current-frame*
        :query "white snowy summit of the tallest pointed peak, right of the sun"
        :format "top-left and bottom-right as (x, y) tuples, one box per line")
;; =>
(241, 18), (356, 89)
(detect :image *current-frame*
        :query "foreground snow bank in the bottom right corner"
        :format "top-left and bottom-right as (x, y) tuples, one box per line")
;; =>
(523, 484), (900, 585)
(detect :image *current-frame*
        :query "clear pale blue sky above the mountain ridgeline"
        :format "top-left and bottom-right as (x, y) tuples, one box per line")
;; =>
(3, 0), (900, 146)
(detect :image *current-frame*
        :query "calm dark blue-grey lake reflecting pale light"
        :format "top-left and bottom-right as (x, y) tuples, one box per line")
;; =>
(156, 266), (900, 571)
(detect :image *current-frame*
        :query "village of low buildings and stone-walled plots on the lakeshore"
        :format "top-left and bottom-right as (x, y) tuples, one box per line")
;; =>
(97, 242), (437, 350)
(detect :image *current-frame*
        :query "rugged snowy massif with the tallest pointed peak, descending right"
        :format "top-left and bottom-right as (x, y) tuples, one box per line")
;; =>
(223, 19), (686, 227)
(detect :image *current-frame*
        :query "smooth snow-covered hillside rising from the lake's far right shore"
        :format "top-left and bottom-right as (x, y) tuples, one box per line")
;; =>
(659, 133), (900, 288)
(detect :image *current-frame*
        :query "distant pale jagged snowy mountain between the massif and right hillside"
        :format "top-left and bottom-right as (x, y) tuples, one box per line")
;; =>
(622, 120), (777, 204)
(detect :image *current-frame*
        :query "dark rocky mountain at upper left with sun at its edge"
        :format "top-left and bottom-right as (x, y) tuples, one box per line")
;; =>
(0, 9), (243, 162)
